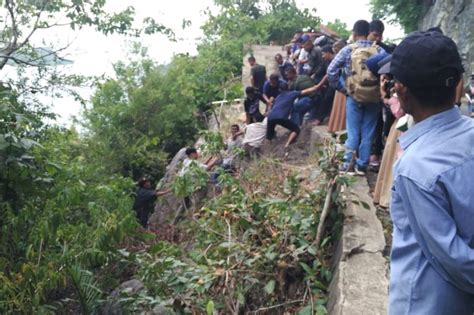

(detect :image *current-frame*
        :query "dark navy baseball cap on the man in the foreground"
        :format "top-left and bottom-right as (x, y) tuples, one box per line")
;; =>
(390, 32), (464, 87)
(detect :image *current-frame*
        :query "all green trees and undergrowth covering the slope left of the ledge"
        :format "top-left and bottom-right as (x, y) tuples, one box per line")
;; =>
(0, 0), (342, 314)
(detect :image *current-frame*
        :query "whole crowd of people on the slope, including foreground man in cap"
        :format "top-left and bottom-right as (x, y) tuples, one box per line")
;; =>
(134, 20), (474, 314)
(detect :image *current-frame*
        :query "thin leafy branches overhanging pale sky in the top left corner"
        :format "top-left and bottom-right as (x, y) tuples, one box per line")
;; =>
(0, 0), (173, 69)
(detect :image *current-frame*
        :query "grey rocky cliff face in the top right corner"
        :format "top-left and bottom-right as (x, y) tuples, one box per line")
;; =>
(419, 0), (474, 78)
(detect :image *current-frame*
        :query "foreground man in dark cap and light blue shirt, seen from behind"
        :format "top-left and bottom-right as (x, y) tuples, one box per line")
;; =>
(389, 32), (474, 315)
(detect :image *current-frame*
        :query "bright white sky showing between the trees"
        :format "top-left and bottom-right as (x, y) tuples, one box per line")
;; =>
(22, 0), (403, 125)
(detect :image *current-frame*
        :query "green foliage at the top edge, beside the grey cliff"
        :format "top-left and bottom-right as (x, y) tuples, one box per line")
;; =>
(370, 0), (423, 33)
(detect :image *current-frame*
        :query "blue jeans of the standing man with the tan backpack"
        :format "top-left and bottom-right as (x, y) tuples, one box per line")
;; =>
(344, 96), (382, 168)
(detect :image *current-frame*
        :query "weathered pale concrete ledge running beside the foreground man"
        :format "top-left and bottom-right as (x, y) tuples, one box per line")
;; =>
(328, 177), (388, 315)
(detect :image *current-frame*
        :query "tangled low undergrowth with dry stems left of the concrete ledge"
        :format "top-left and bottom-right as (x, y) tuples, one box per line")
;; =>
(109, 139), (346, 314)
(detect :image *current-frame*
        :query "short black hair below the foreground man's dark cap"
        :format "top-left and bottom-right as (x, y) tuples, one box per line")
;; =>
(408, 74), (461, 107)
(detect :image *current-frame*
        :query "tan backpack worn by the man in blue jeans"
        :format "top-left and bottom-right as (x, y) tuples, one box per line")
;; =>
(346, 43), (381, 103)
